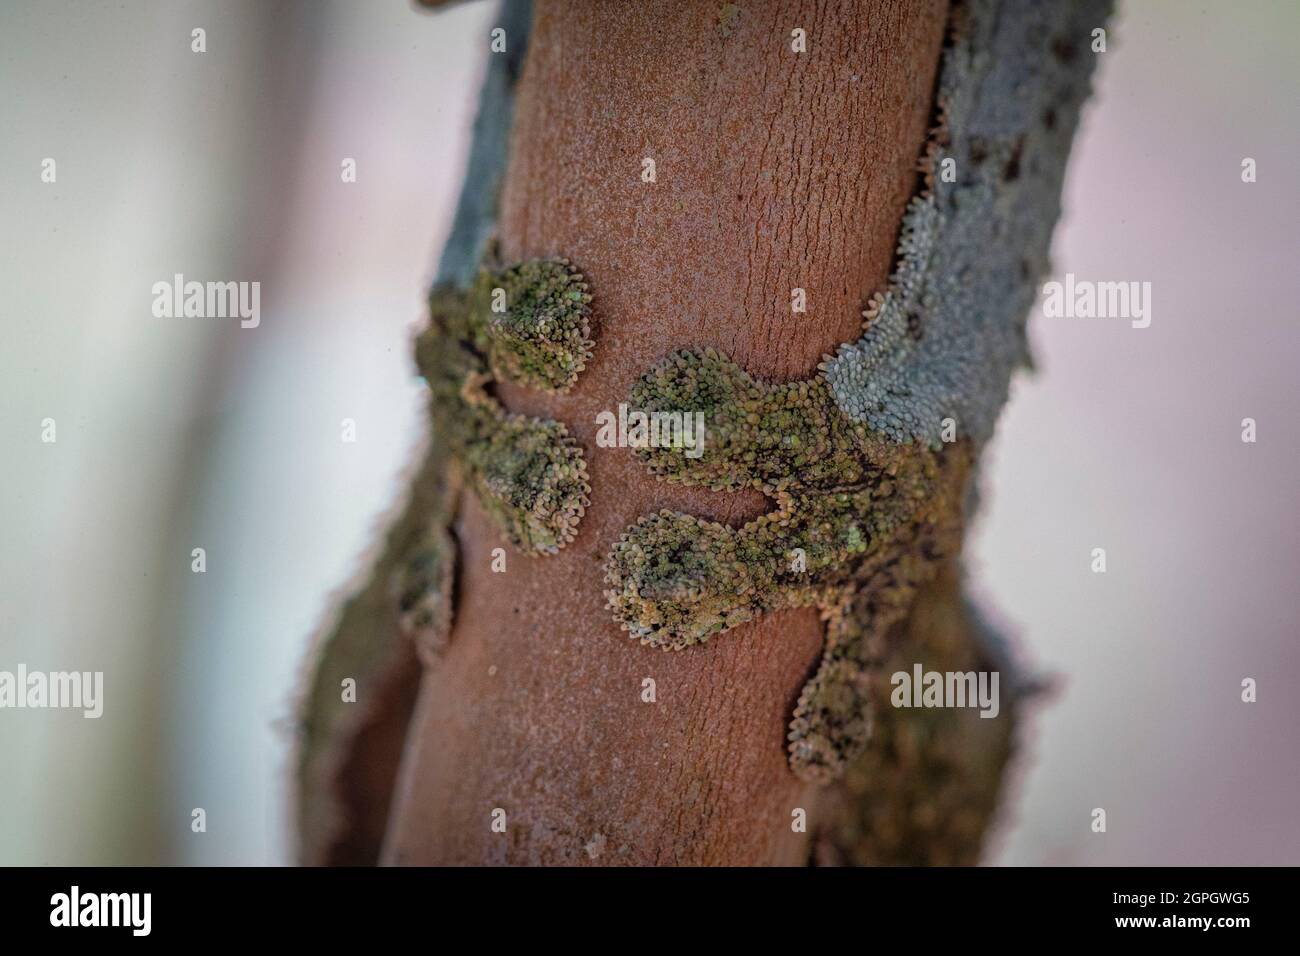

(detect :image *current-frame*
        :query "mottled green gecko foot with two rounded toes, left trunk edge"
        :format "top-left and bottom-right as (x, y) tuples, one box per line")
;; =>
(416, 259), (592, 556)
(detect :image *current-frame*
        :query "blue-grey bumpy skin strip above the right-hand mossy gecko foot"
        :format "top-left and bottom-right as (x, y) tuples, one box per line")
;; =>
(826, 0), (1110, 444)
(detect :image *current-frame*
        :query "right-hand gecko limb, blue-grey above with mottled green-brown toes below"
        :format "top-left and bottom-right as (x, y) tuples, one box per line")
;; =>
(606, 0), (1109, 783)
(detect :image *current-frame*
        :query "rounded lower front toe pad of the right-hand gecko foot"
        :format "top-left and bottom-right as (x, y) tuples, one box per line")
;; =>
(605, 511), (753, 650)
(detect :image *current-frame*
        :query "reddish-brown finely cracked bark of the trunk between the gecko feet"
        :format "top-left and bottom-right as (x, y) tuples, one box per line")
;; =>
(386, 0), (945, 864)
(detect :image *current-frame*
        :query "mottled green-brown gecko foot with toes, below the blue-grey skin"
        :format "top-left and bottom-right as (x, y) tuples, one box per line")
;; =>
(606, 349), (969, 780)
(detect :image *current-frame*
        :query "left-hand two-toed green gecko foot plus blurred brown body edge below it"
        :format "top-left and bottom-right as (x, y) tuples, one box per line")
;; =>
(298, 248), (593, 862)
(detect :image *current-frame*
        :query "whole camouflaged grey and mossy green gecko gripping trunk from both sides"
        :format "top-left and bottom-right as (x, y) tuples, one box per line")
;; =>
(300, 0), (1110, 862)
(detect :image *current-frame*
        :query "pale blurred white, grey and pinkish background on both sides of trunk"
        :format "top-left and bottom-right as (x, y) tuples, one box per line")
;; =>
(0, 0), (1300, 864)
